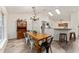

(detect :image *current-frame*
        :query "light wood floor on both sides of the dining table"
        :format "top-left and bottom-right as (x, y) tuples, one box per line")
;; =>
(4, 39), (79, 53)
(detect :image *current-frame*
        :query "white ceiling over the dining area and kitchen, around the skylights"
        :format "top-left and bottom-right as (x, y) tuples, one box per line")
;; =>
(6, 6), (79, 18)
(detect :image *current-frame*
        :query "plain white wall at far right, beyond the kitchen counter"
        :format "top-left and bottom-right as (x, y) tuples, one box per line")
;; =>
(71, 13), (79, 37)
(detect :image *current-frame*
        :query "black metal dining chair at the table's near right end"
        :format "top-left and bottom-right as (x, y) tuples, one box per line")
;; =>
(41, 37), (53, 53)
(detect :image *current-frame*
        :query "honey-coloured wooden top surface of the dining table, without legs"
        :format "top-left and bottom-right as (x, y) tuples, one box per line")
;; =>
(27, 32), (49, 41)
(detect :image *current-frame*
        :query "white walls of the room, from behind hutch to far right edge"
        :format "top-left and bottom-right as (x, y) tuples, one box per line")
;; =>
(7, 10), (79, 39)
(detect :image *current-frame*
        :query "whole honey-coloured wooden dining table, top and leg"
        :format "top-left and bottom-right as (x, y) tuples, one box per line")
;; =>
(27, 32), (49, 52)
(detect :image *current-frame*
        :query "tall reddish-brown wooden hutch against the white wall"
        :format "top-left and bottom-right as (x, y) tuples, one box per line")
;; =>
(17, 19), (27, 39)
